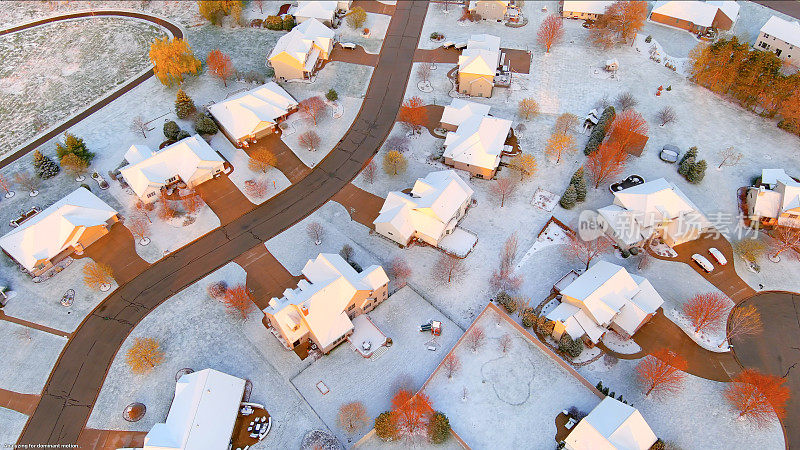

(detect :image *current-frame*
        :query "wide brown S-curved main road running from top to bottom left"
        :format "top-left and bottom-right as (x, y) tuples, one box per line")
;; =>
(19, 1), (428, 444)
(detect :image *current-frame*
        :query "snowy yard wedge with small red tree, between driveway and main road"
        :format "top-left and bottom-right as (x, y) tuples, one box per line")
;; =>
(281, 96), (364, 167)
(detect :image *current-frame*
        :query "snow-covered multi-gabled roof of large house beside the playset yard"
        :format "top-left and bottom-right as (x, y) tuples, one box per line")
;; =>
(264, 253), (389, 347)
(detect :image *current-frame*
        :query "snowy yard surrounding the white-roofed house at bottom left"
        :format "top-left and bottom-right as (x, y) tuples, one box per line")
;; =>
(87, 263), (324, 448)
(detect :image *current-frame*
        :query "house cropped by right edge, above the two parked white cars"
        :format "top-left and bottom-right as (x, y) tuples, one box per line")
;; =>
(747, 169), (800, 228)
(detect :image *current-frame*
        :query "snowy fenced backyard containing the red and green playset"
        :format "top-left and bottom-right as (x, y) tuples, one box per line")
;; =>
(292, 287), (463, 442)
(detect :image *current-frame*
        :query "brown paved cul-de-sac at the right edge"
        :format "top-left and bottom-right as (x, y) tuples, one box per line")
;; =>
(731, 291), (800, 448)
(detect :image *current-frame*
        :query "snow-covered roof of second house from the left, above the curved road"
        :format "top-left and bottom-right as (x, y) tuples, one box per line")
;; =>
(120, 134), (225, 197)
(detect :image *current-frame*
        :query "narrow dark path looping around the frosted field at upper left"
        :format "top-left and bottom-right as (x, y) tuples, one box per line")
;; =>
(0, 10), (183, 169)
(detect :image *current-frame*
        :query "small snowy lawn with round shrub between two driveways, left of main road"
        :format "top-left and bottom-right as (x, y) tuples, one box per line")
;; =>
(211, 133), (292, 205)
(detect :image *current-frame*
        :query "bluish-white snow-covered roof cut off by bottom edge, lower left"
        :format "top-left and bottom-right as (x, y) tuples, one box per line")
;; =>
(144, 369), (245, 450)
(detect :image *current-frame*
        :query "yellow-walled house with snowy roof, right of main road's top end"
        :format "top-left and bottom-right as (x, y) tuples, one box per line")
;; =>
(458, 34), (500, 98)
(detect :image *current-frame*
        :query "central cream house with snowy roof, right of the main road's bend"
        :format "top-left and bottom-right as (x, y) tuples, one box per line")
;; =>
(373, 170), (473, 246)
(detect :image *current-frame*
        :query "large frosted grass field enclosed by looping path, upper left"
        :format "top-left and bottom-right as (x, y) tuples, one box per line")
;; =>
(0, 17), (166, 155)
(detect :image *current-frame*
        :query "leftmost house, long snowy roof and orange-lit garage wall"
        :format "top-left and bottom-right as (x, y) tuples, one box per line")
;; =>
(0, 187), (120, 277)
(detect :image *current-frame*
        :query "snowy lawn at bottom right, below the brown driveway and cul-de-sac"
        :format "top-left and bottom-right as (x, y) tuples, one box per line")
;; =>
(578, 360), (785, 449)
